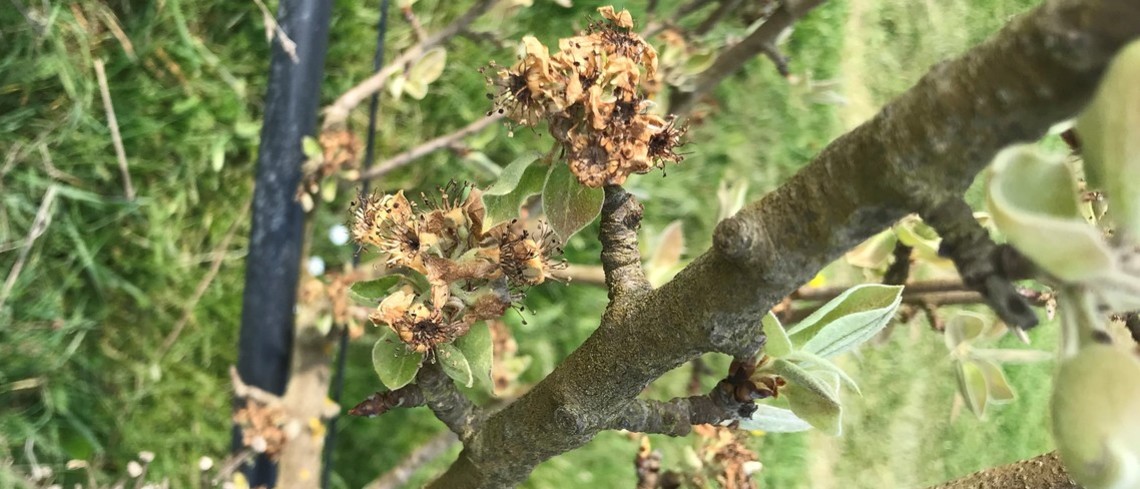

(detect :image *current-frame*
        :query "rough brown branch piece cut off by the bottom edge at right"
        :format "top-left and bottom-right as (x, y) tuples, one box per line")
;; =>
(930, 451), (1081, 489)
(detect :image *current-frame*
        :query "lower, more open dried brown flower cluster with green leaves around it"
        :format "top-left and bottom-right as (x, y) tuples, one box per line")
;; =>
(351, 182), (562, 352)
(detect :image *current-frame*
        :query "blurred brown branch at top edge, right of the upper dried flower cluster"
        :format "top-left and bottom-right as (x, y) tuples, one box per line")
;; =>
(669, 0), (825, 115)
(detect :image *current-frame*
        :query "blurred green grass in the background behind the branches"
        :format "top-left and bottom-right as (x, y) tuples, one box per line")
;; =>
(0, 0), (1052, 488)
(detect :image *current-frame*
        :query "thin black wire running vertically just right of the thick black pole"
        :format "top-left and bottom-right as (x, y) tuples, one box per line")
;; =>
(320, 0), (388, 489)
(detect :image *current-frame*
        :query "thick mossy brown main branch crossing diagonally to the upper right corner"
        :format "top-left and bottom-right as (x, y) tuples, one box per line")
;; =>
(434, 0), (1140, 488)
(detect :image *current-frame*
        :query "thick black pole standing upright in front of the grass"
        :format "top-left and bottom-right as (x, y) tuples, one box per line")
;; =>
(234, 0), (332, 487)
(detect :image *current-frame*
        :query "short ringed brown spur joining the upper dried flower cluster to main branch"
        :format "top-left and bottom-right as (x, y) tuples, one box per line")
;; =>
(597, 186), (652, 302)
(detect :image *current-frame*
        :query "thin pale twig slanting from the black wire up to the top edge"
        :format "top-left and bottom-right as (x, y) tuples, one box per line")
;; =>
(324, 0), (495, 129)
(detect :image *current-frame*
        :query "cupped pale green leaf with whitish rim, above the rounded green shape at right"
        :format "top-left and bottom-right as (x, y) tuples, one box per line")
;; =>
(986, 146), (1116, 282)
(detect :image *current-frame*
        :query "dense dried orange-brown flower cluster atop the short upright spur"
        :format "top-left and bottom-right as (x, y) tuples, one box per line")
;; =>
(488, 7), (684, 187)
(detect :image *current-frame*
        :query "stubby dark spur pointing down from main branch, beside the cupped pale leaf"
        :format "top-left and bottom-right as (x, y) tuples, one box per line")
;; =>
(921, 196), (1037, 329)
